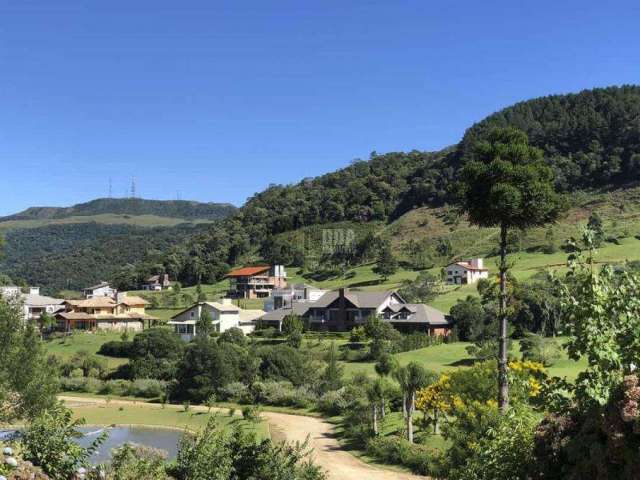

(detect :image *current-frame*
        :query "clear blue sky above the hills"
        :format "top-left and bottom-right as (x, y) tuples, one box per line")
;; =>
(0, 0), (640, 214)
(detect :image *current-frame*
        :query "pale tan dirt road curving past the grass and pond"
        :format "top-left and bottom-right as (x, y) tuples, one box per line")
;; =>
(58, 395), (426, 480)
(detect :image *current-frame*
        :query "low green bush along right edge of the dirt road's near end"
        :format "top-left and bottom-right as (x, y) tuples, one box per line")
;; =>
(366, 436), (440, 476)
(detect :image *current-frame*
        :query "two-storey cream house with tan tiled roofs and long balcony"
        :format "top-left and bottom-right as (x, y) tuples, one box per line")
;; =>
(56, 293), (157, 332)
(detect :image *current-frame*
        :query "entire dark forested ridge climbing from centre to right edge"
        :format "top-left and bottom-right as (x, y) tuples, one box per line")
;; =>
(240, 86), (640, 238)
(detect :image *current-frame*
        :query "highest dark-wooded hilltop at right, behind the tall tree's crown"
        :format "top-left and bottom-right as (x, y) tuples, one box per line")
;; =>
(458, 85), (640, 191)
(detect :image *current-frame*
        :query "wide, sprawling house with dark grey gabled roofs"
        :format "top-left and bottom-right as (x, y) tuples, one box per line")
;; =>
(260, 288), (451, 336)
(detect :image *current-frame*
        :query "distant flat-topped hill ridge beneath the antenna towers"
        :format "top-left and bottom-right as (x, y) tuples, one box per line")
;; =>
(0, 198), (236, 222)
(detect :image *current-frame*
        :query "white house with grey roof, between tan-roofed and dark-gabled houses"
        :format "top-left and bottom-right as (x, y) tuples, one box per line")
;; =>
(169, 298), (265, 342)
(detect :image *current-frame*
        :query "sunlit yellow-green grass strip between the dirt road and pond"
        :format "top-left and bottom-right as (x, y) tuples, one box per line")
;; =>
(70, 403), (269, 438)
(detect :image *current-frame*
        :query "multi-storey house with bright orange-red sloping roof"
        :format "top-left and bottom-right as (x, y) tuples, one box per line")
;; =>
(227, 265), (287, 298)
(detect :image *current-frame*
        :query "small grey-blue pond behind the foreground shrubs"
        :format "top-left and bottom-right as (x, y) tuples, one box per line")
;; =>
(0, 426), (183, 465)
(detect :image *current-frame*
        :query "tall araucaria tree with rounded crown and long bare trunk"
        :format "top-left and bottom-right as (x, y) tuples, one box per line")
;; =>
(459, 128), (561, 413)
